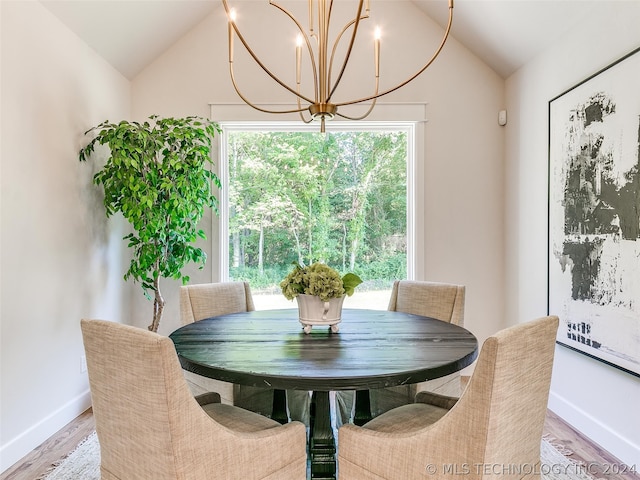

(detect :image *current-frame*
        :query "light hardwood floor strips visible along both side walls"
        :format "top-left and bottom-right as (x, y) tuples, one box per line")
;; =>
(0, 409), (640, 480)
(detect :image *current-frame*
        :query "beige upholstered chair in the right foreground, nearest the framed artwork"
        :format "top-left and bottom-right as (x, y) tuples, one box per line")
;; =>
(338, 316), (558, 480)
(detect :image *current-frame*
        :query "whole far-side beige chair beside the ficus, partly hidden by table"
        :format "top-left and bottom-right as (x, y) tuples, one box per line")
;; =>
(180, 282), (273, 416)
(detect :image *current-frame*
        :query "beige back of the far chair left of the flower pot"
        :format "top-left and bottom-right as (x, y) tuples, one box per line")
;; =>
(180, 282), (255, 325)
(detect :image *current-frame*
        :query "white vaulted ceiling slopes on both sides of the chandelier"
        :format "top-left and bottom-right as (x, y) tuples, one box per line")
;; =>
(40, 0), (604, 79)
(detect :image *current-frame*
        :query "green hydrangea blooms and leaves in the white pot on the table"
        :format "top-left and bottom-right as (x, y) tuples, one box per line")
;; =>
(280, 262), (362, 302)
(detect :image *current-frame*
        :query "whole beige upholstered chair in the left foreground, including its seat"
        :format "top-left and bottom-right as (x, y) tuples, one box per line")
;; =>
(81, 320), (307, 480)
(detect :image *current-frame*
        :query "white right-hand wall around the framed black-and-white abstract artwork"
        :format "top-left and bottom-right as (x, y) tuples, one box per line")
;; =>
(506, 2), (640, 465)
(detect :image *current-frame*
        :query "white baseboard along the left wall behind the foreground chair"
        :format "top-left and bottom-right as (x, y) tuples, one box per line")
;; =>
(0, 389), (91, 472)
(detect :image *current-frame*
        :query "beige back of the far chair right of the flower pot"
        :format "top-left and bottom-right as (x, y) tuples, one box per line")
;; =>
(388, 280), (465, 326)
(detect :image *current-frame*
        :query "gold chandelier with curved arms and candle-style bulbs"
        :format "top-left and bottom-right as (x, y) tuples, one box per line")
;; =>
(222, 0), (453, 132)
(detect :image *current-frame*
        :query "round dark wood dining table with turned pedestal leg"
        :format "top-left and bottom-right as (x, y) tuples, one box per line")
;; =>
(169, 308), (478, 478)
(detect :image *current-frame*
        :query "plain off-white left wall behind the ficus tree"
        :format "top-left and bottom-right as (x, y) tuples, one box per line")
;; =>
(0, 0), (130, 471)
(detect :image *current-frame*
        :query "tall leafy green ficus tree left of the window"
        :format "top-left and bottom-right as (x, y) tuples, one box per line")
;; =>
(79, 115), (221, 332)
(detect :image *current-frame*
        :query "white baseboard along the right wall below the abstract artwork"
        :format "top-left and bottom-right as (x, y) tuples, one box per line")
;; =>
(549, 392), (640, 471)
